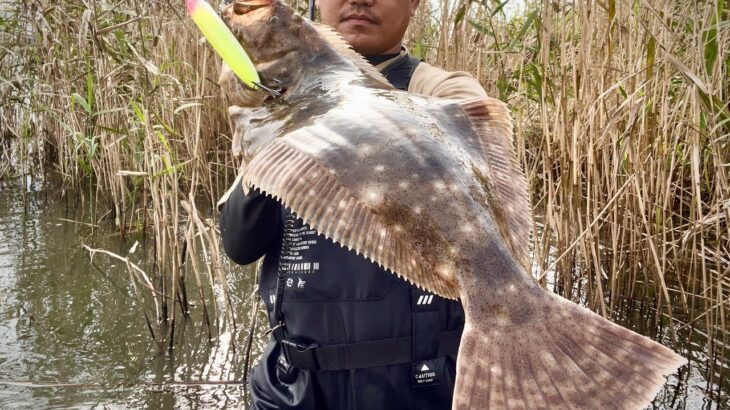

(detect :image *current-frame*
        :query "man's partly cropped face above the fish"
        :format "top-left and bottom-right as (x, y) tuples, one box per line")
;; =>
(317, 0), (420, 55)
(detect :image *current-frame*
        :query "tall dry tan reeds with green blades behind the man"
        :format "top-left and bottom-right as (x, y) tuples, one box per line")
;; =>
(0, 0), (730, 397)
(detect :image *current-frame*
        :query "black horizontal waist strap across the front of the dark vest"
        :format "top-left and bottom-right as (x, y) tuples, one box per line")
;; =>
(281, 329), (461, 371)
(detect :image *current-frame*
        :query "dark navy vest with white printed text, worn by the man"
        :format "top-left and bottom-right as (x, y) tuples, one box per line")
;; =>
(251, 54), (464, 410)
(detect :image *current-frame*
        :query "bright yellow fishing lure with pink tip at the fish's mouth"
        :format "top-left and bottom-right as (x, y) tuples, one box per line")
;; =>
(187, 0), (261, 89)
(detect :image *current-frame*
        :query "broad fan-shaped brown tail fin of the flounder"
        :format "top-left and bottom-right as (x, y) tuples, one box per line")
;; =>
(453, 293), (686, 409)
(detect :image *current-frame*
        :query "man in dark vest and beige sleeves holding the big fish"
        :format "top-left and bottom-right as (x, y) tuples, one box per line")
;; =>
(221, 0), (486, 410)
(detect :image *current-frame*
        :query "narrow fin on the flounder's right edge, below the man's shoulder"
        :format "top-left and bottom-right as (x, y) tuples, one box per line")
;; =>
(459, 98), (532, 267)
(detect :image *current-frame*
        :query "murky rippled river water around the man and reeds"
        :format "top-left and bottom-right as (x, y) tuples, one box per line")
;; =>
(0, 180), (730, 409)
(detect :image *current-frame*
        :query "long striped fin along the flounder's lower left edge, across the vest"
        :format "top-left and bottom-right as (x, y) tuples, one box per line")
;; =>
(242, 141), (459, 299)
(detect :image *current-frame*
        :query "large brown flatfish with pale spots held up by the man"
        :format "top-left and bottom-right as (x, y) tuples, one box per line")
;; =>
(215, 0), (684, 409)
